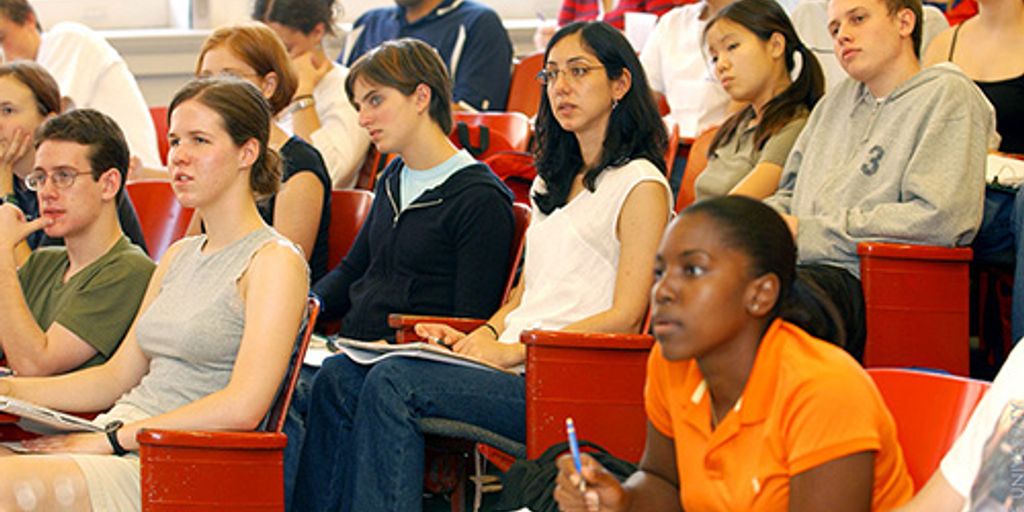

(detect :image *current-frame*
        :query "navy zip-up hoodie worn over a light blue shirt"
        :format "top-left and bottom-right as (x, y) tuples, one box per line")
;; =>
(313, 158), (515, 340)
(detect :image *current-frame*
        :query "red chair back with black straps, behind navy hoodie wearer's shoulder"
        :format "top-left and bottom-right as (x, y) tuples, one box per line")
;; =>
(449, 112), (532, 160)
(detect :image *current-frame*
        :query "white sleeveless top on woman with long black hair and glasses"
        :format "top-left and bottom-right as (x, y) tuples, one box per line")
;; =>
(499, 160), (672, 352)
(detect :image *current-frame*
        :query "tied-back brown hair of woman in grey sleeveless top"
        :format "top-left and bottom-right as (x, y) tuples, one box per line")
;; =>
(167, 78), (282, 198)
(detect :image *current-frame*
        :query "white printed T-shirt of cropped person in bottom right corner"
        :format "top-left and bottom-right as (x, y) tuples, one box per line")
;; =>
(939, 343), (1024, 511)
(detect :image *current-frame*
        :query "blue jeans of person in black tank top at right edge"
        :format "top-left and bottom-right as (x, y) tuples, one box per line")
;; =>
(972, 187), (1024, 342)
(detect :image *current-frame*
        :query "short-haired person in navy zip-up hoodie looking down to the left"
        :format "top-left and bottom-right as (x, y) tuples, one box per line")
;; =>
(305, 38), (514, 340)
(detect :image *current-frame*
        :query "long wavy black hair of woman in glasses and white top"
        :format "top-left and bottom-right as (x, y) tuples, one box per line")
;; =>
(534, 22), (668, 214)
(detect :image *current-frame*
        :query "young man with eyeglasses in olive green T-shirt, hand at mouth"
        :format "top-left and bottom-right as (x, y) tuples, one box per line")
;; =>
(0, 109), (155, 375)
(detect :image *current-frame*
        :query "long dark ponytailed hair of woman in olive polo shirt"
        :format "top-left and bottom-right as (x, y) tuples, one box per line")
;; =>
(703, 0), (825, 155)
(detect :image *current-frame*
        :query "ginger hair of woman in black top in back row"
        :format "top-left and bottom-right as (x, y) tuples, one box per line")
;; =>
(196, 23), (299, 114)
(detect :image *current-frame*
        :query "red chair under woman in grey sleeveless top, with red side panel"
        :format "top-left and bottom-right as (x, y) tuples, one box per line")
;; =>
(137, 296), (319, 512)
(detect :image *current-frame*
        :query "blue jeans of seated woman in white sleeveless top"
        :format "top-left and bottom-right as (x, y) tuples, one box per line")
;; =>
(291, 355), (526, 512)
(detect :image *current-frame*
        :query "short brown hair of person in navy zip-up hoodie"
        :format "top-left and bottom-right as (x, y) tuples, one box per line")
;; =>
(345, 38), (452, 133)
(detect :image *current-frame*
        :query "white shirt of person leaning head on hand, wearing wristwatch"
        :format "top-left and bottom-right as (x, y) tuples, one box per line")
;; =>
(278, 62), (370, 189)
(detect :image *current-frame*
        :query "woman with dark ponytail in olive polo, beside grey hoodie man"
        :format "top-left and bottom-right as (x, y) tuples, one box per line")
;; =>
(694, 0), (824, 201)
